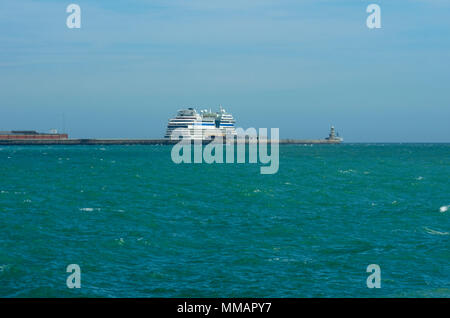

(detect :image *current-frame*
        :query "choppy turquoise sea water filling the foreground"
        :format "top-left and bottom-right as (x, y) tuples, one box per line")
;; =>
(0, 144), (450, 297)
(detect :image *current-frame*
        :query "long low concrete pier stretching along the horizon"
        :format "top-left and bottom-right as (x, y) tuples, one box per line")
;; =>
(0, 139), (341, 146)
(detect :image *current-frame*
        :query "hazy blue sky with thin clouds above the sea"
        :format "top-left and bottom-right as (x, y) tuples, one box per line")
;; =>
(0, 0), (450, 142)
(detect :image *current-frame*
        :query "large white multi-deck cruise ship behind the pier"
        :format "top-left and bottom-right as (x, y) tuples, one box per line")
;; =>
(164, 106), (236, 140)
